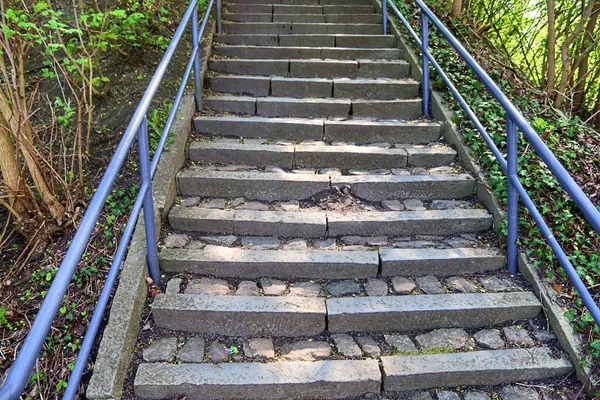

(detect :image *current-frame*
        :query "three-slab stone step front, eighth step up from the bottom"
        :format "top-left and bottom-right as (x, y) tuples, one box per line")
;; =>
(203, 95), (422, 120)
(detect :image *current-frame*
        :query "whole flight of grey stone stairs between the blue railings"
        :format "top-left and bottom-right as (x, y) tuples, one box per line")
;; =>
(133, 0), (572, 400)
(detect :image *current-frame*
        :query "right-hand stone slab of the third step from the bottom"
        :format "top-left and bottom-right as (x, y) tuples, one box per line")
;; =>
(379, 247), (506, 277)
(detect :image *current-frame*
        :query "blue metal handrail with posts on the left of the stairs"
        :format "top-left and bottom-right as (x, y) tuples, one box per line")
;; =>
(0, 0), (221, 400)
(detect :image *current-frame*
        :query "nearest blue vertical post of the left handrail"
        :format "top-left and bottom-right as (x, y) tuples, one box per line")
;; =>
(138, 116), (160, 284)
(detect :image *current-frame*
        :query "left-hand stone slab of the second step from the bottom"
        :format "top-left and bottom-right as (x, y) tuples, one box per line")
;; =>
(152, 293), (326, 337)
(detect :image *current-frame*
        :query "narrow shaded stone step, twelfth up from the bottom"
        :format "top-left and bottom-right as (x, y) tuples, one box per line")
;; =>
(214, 34), (396, 48)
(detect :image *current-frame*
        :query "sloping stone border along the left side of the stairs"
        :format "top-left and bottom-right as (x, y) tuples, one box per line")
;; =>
(86, 20), (215, 399)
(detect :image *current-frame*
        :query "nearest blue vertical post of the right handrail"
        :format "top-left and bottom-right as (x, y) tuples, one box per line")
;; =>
(506, 118), (519, 275)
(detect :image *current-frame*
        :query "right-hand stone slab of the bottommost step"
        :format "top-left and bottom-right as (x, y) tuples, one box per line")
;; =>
(381, 347), (573, 390)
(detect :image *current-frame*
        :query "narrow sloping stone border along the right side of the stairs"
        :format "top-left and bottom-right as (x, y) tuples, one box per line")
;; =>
(371, 0), (600, 393)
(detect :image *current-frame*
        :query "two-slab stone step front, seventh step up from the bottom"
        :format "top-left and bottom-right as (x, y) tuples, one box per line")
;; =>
(194, 116), (441, 144)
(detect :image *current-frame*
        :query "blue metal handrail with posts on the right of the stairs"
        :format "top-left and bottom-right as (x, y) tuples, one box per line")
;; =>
(382, 0), (600, 326)
